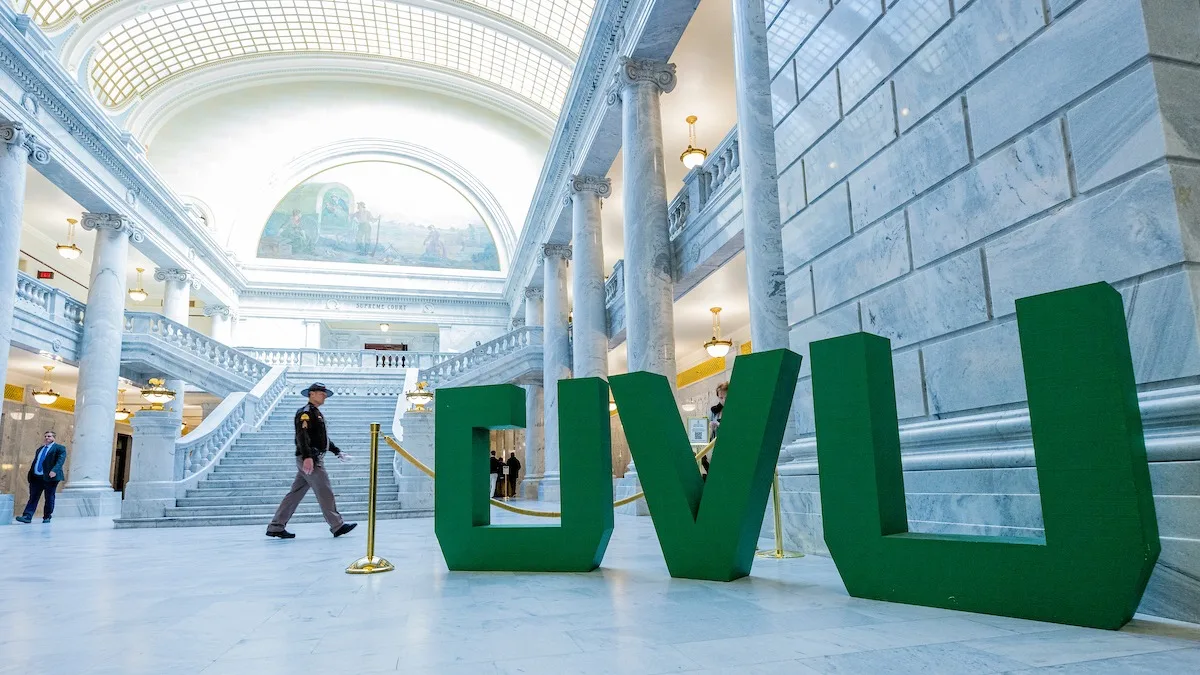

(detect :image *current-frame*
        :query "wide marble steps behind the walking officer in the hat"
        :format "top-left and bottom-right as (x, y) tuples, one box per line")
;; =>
(116, 395), (432, 530)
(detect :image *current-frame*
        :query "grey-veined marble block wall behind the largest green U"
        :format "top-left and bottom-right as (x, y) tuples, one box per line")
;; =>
(764, 0), (1200, 621)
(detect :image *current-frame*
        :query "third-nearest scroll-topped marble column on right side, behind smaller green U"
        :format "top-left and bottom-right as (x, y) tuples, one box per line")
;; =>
(538, 244), (571, 501)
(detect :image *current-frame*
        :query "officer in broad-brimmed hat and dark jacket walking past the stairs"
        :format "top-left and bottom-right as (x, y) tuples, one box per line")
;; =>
(266, 382), (358, 539)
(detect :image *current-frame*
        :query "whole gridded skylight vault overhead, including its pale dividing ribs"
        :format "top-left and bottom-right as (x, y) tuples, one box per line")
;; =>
(17, 0), (595, 118)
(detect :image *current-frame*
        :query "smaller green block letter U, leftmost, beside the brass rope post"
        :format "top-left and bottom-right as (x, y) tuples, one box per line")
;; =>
(433, 378), (613, 572)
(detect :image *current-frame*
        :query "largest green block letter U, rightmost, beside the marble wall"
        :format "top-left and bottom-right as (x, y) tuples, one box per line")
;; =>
(811, 283), (1159, 629)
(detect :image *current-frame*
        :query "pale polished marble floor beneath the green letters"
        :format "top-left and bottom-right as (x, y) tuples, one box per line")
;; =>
(0, 506), (1200, 675)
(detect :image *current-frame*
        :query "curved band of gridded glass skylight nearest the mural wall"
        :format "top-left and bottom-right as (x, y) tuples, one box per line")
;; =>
(91, 0), (571, 114)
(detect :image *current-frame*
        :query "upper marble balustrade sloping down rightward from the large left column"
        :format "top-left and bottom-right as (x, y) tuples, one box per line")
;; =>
(121, 312), (271, 395)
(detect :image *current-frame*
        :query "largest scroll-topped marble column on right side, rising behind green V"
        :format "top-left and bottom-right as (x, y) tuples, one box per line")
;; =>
(608, 56), (676, 389)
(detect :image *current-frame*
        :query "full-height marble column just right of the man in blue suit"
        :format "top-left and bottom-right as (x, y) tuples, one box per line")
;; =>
(59, 213), (144, 515)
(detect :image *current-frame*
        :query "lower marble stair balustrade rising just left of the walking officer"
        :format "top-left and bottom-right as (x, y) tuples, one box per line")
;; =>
(174, 366), (287, 485)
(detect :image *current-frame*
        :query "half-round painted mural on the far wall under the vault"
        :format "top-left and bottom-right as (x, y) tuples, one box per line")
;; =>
(258, 162), (500, 271)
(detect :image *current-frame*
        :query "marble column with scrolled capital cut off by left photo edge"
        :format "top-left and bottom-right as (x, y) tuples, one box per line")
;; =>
(0, 120), (50, 391)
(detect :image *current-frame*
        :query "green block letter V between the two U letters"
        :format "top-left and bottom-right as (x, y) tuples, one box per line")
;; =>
(611, 350), (800, 581)
